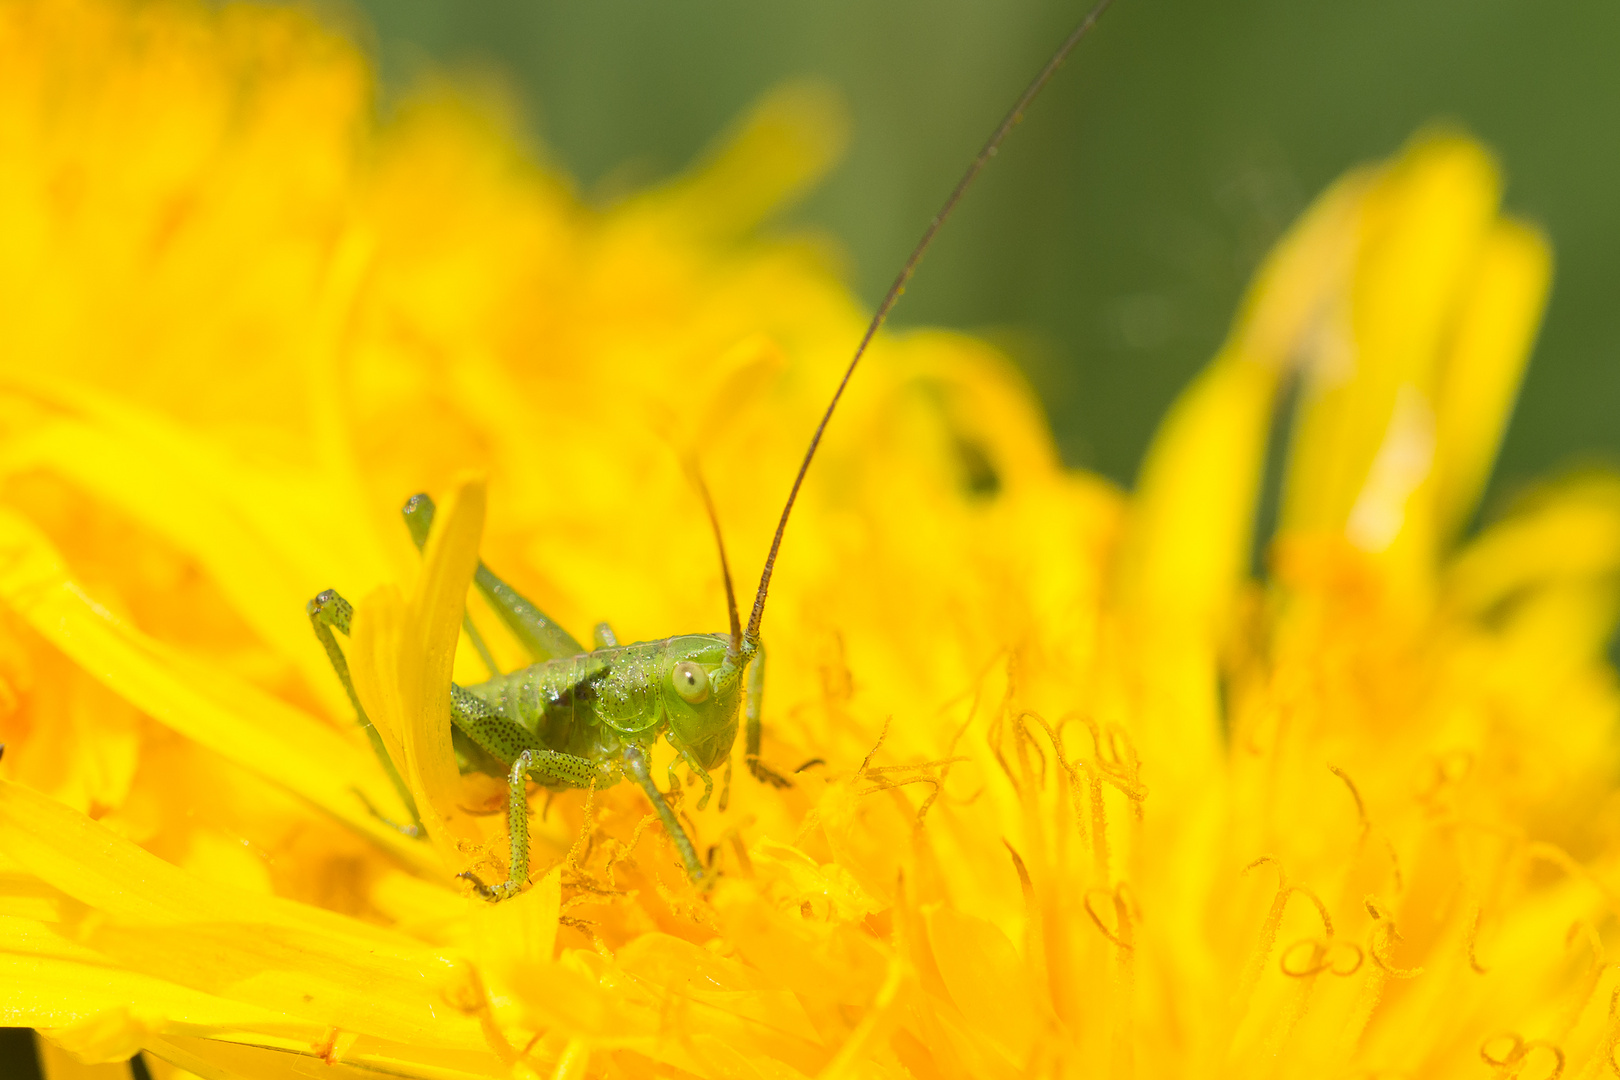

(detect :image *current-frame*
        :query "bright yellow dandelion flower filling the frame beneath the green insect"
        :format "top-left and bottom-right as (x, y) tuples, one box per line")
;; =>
(0, 0), (1620, 1080)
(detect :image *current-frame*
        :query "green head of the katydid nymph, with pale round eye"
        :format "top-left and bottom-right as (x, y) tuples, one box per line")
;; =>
(661, 633), (752, 769)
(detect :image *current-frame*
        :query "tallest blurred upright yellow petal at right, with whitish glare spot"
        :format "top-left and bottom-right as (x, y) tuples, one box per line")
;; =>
(1281, 136), (1500, 594)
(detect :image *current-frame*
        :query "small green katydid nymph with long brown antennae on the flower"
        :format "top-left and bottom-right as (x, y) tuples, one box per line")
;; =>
(308, 0), (1111, 900)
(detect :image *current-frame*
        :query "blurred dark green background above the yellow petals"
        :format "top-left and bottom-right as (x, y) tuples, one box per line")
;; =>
(340, 0), (1620, 502)
